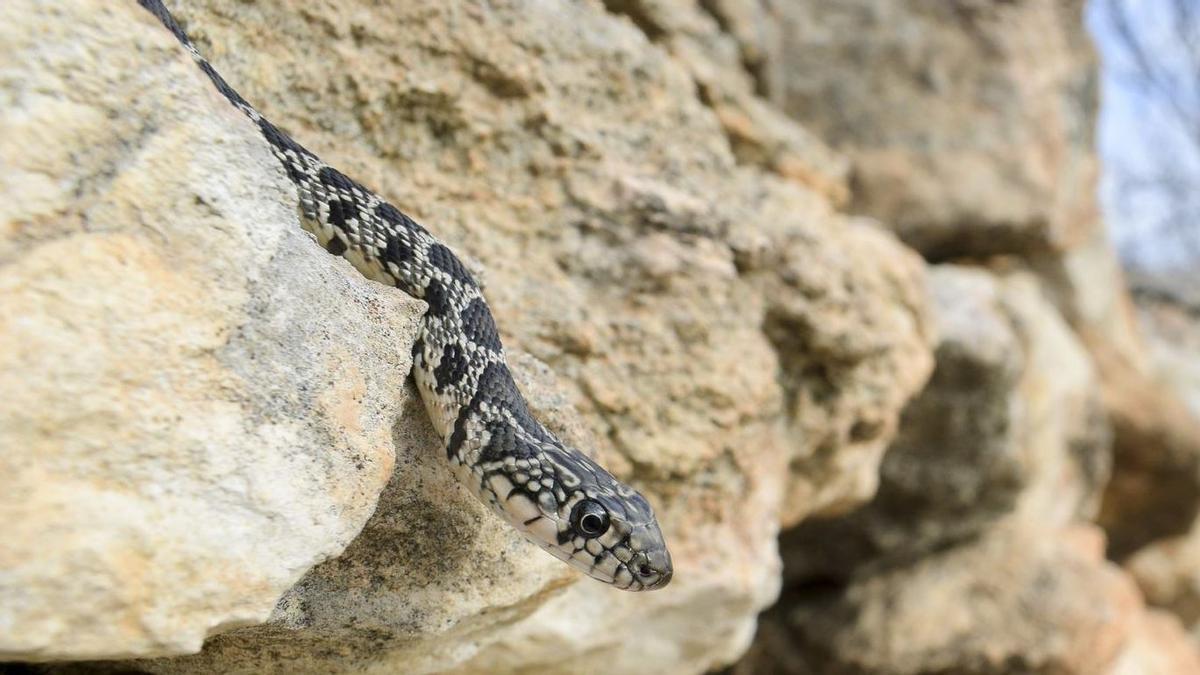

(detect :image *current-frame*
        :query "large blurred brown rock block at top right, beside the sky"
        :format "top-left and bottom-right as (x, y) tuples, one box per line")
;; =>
(753, 0), (1098, 259)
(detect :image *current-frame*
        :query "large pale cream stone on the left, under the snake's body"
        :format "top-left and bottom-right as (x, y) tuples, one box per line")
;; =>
(0, 1), (436, 659)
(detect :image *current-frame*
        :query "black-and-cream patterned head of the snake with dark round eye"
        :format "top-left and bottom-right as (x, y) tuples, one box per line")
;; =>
(485, 443), (672, 591)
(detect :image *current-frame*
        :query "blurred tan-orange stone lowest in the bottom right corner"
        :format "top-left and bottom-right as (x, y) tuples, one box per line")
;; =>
(739, 522), (1176, 675)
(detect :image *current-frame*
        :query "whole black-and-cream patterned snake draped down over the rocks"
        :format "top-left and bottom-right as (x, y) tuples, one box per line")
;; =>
(138, 0), (673, 591)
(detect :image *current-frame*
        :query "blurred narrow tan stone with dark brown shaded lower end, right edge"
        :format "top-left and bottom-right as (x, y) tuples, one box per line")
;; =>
(1031, 229), (1200, 558)
